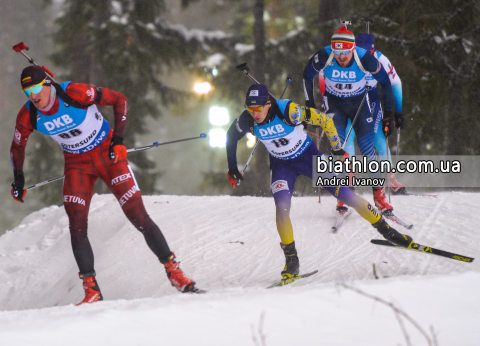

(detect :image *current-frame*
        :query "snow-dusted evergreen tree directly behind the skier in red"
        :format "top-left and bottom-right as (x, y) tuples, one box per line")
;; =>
(27, 0), (234, 203)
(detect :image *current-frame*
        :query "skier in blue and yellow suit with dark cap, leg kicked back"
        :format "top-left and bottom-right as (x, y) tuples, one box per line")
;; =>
(227, 84), (412, 278)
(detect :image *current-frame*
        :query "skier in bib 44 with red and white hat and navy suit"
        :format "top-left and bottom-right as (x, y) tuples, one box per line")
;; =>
(303, 27), (393, 213)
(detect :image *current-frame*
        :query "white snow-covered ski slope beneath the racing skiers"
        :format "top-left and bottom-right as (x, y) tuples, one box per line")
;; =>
(0, 193), (480, 346)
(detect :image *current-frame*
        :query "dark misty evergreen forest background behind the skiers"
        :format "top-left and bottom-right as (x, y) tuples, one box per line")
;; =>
(0, 0), (480, 233)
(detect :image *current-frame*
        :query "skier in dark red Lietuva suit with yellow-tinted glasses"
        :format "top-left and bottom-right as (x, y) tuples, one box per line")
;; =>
(10, 66), (199, 304)
